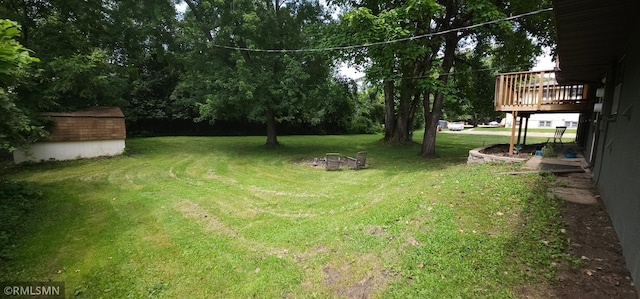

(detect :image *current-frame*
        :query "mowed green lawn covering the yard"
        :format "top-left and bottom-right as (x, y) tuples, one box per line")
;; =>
(0, 134), (565, 298)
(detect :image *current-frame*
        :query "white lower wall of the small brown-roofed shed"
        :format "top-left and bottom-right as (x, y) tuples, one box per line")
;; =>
(13, 139), (125, 163)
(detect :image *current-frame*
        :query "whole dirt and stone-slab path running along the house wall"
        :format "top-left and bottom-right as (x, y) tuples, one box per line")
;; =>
(478, 139), (639, 299)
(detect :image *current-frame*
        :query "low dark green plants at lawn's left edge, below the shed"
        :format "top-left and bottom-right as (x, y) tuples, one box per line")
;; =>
(0, 181), (42, 259)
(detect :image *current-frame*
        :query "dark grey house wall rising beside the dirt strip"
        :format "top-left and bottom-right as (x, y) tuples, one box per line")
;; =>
(592, 34), (640, 283)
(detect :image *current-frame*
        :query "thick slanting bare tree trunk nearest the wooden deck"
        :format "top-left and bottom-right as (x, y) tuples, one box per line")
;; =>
(420, 33), (459, 157)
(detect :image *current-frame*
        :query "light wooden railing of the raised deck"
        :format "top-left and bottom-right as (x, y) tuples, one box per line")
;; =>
(495, 71), (591, 112)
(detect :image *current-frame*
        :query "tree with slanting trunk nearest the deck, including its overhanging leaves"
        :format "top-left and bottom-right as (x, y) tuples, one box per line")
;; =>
(420, 0), (552, 157)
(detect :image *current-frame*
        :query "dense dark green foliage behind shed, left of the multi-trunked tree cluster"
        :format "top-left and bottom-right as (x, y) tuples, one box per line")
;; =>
(0, 0), (380, 137)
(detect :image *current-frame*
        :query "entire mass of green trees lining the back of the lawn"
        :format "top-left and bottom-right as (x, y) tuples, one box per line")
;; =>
(0, 0), (554, 157)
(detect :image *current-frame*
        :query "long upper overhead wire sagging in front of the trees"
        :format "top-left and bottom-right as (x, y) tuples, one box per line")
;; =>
(212, 7), (553, 53)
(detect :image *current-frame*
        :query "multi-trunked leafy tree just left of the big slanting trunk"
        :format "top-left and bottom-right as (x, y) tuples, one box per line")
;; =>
(330, 1), (439, 143)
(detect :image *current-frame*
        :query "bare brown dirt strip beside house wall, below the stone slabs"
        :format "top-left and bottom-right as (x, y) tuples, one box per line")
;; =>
(514, 178), (638, 299)
